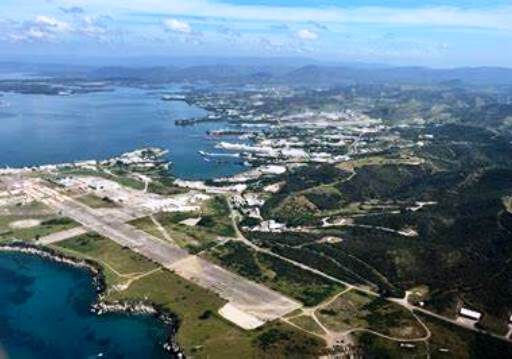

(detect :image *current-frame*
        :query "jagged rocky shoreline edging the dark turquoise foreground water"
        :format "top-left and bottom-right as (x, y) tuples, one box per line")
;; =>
(0, 242), (185, 359)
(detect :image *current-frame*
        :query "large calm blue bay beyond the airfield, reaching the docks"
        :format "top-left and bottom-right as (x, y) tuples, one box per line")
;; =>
(0, 88), (243, 179)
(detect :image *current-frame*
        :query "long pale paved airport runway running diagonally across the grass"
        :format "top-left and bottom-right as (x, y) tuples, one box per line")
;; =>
(26, 181), (301, 329)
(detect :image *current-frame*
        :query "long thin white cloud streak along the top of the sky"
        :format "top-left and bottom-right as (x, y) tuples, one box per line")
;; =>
(62, 0), (512, 30)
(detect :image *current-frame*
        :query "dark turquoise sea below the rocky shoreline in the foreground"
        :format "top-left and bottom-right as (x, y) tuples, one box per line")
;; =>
(0, 253), (171, 359)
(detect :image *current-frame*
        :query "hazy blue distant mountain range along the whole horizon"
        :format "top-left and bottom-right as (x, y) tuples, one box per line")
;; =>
(0, 59), (512, 86)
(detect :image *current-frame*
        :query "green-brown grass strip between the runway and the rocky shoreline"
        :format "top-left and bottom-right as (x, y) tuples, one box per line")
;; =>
(53, 234), (325, 358)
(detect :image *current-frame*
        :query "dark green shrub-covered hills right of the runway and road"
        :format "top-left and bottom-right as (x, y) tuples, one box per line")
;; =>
(258, 125), (512, 333)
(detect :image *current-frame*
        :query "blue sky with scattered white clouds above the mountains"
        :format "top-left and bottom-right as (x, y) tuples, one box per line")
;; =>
(0, 0), (512, 67)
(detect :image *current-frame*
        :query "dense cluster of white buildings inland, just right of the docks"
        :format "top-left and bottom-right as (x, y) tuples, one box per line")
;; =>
(210, 112), (406, 165)
